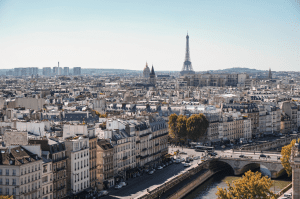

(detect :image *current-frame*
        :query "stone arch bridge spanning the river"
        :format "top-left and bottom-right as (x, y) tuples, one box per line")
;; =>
(209, 157), (285, 178)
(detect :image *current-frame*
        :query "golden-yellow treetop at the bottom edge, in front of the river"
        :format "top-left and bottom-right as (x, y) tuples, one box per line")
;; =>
(216, 170), (276, 199)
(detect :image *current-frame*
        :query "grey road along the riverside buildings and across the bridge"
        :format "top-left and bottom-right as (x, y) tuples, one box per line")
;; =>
(101, 147), (280, 199)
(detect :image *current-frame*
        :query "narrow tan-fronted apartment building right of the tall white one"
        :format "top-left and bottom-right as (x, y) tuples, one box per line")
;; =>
(96, 139), (115, 190)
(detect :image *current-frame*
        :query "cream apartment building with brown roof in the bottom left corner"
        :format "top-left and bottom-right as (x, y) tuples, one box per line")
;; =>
(0, 146), (43, 199)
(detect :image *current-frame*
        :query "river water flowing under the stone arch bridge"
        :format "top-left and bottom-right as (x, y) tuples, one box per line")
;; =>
(184, 167), (292, 199)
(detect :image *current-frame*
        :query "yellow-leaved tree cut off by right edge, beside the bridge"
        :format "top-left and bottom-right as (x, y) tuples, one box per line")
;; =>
(280, 138), (300, 177)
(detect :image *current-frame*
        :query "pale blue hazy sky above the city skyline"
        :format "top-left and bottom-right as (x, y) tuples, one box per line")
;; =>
(0, 0), (300, 71)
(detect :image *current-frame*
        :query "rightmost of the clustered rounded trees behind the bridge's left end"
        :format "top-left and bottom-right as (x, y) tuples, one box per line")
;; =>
(186, 113), (209, 140)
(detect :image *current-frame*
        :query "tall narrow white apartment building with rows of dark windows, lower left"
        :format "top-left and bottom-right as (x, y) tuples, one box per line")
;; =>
(65, 135), (90, 195)
